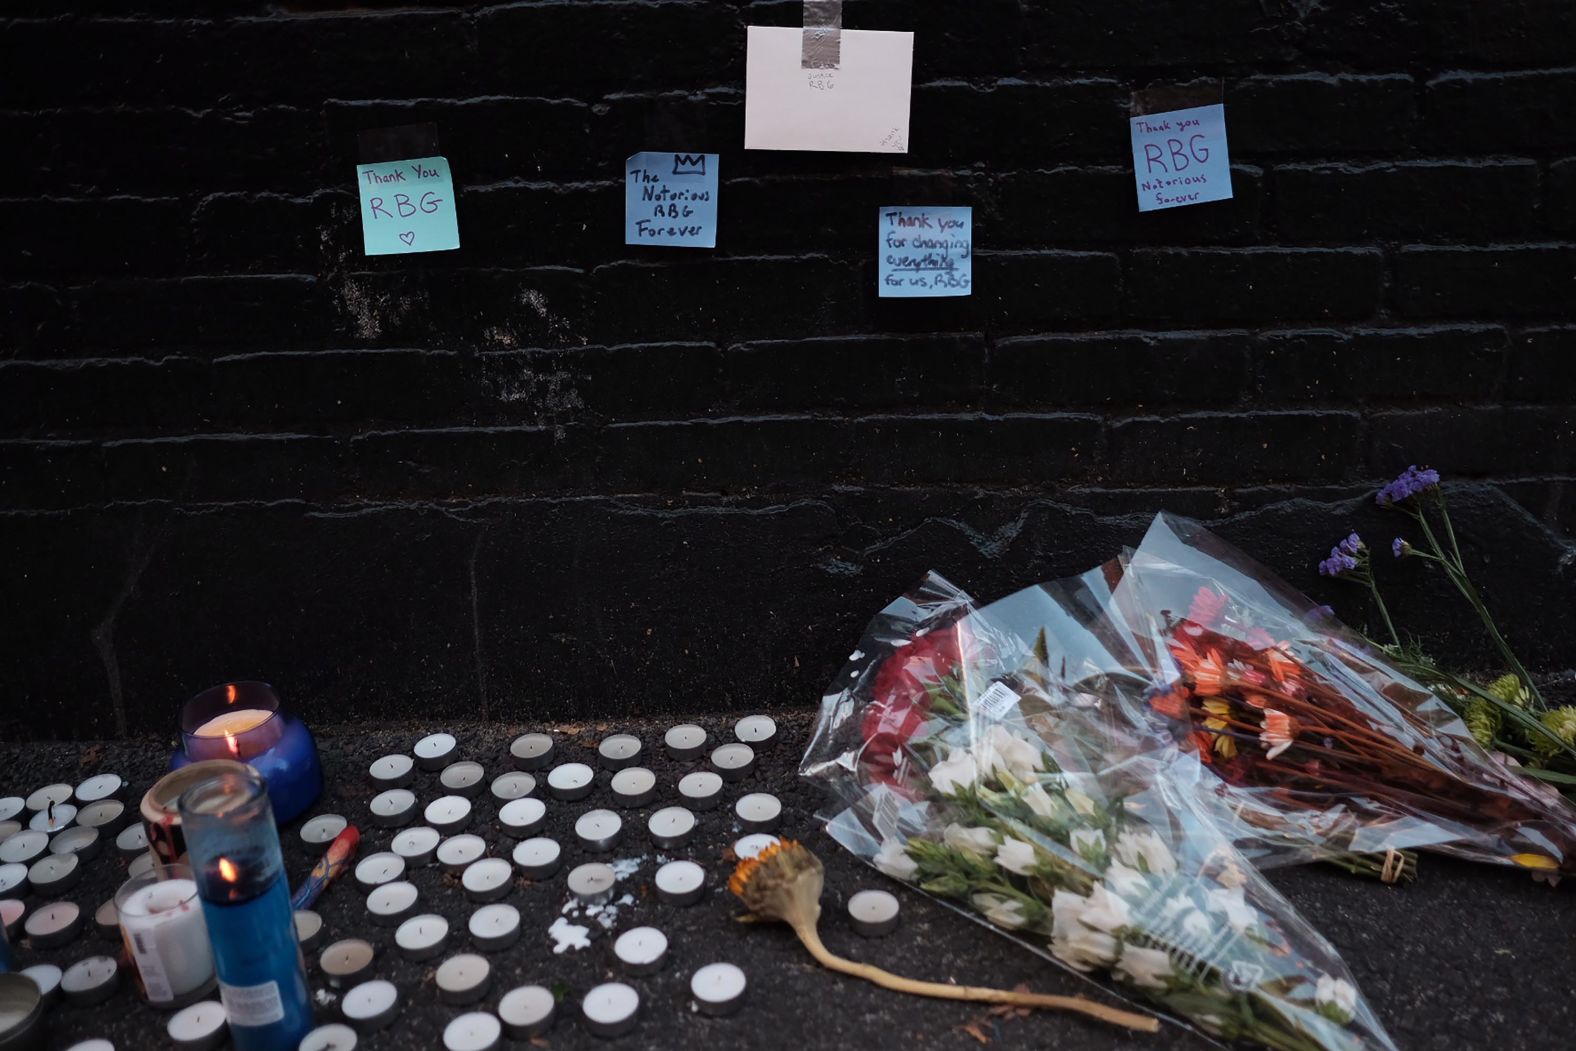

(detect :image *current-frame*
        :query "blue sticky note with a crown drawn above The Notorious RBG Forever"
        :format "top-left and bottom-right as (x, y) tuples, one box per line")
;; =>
(624, 151), (719, 247)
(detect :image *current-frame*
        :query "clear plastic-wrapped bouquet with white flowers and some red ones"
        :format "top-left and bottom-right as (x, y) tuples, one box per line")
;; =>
(801, 575), (1393, 1051)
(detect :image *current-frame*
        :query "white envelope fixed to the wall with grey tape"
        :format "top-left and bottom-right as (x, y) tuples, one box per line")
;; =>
(744, 25), (914, 153)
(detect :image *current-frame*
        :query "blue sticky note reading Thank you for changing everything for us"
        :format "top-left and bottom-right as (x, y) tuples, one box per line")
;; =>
(876, 205), (974, 296)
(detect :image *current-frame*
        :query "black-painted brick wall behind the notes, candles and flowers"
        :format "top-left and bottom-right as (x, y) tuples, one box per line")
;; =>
(0, 0), (1576, 736)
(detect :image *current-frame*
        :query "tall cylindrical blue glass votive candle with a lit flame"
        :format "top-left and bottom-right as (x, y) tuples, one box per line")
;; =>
(180, 769), (312, 1051)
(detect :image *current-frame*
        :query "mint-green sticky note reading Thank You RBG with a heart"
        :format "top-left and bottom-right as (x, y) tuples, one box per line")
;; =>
(356, 158), (460, 255)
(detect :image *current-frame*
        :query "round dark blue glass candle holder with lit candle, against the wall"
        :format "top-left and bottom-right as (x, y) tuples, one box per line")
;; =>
(170, 682), (323, 821)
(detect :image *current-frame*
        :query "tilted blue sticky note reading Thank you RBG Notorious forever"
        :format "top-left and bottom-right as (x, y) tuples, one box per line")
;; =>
(1128, 106), (1231, 211)
